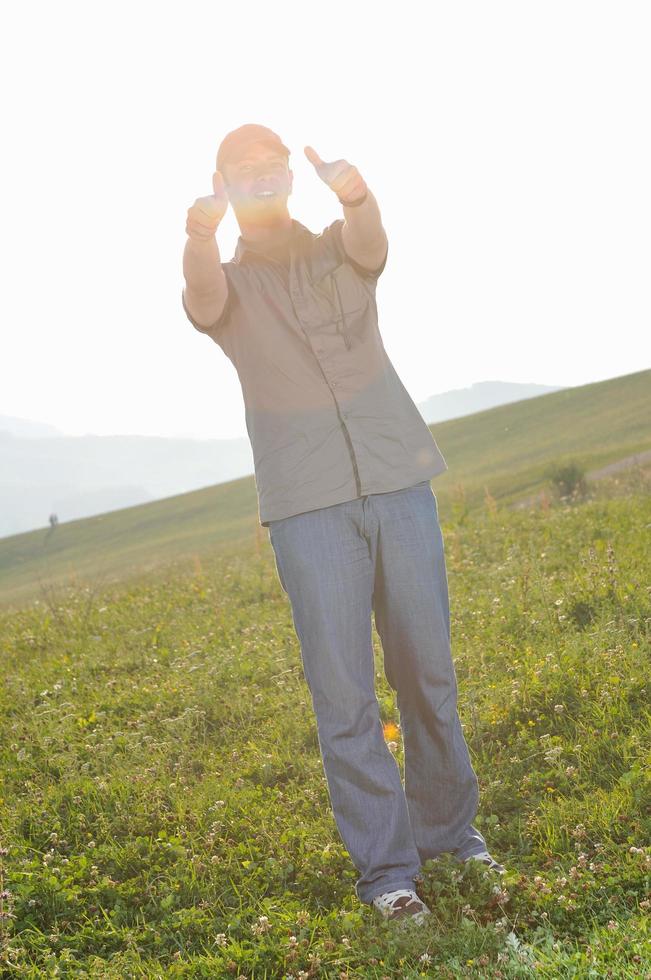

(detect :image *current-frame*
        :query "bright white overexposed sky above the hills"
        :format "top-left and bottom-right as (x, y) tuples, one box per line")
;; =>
(0, 0), (651, 438)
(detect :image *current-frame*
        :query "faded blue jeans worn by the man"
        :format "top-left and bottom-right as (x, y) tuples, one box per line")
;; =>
(269, 480), (486, 904)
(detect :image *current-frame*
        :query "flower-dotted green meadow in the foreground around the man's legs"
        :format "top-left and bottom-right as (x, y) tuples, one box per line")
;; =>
(0, 466), (651, 980)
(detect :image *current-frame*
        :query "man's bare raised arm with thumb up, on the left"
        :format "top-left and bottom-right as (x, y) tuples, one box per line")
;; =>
(183, 171), (228, 327)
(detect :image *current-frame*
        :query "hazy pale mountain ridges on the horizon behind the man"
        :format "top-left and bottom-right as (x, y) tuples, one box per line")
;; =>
(0, 381), (559, 538)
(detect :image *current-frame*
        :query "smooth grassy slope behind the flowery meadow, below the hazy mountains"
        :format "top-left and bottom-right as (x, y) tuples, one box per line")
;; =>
(0, 371), (651, 605)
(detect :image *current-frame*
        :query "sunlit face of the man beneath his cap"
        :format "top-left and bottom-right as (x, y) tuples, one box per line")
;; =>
(222, 143), (294, 216)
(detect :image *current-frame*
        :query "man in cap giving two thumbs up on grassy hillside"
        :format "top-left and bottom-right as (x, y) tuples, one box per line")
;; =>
(182, 124), (504, 922)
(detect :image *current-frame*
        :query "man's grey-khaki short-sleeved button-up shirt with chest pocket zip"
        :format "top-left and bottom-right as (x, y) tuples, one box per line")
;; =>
(182, 218), (447, 527)
